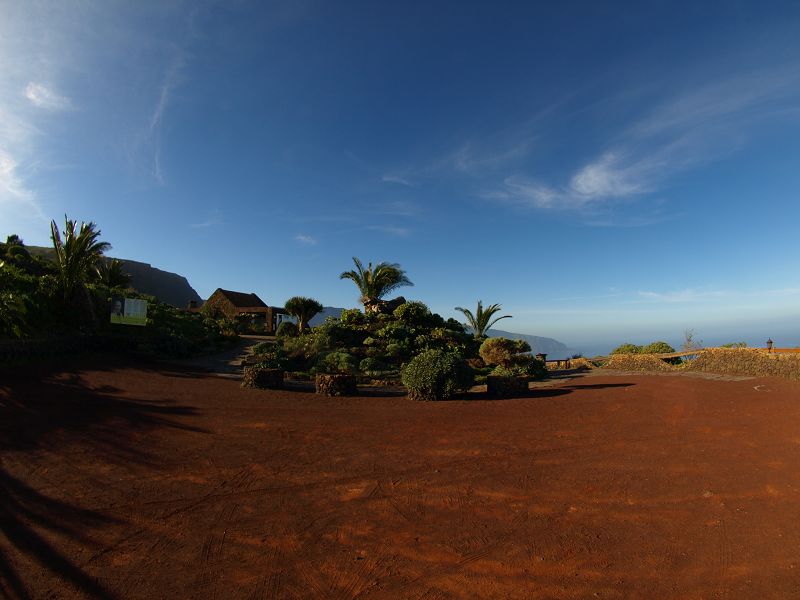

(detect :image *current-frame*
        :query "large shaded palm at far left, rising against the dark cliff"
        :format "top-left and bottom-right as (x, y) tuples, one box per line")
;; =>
(50, 215), (111, 303)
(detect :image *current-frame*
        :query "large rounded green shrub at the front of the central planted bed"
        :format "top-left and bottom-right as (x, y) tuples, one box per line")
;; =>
(401, 350), (472, 400)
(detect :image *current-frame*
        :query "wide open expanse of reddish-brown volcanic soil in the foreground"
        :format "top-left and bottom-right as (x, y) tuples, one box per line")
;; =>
(0, 364), (800, 599)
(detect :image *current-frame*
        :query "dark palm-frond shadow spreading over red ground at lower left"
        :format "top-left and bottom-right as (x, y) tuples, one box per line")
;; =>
(0, 364), (206, 599)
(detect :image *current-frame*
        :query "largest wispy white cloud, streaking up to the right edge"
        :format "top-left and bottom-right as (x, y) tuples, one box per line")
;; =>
(488, 66), (800, 216)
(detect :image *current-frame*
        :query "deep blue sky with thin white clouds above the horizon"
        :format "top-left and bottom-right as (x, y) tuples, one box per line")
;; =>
(0, 0), (800, 352)
